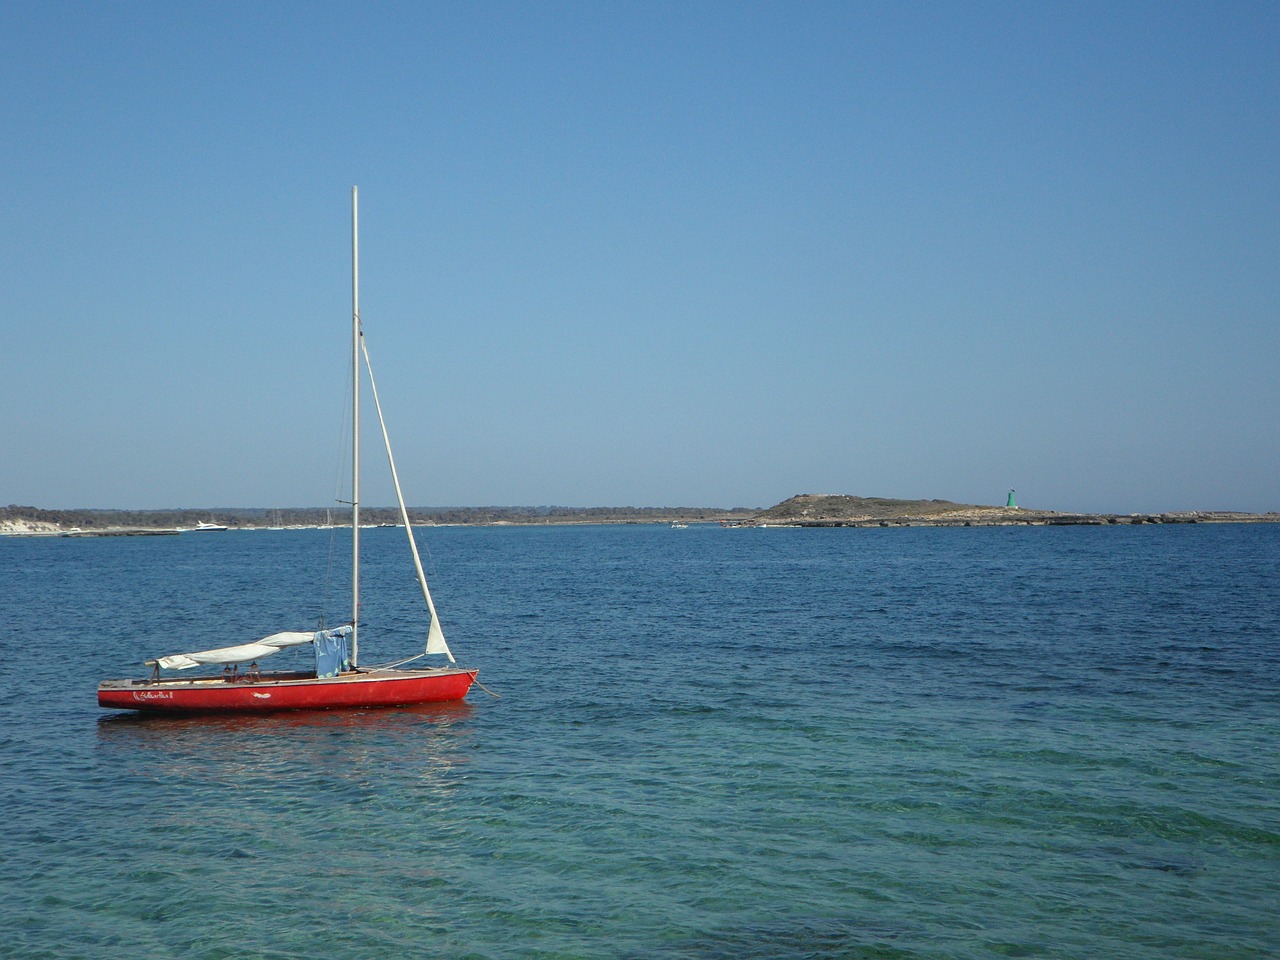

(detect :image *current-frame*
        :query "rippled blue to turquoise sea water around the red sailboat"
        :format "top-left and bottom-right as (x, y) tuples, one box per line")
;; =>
(0, 525), (1280, 960)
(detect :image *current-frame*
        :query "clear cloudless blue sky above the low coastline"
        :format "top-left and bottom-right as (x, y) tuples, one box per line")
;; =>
(0, 3), (1280, 512)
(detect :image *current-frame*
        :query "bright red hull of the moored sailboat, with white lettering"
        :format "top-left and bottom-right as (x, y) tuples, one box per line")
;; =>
(97, 668), (477, 713)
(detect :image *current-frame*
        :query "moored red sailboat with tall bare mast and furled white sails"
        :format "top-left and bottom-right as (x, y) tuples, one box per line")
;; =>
(97, 188), (477, 714)
